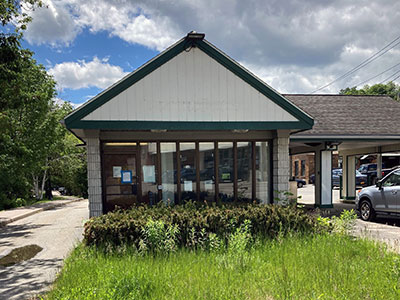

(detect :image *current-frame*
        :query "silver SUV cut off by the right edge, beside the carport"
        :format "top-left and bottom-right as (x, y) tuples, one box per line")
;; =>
(356, 168), (400, 221)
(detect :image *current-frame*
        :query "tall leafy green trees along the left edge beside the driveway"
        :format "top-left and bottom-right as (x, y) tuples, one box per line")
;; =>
(0, 0), (86, 209)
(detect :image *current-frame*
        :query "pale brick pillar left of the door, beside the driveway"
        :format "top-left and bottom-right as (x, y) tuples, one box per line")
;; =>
(86, 137), (103, 217)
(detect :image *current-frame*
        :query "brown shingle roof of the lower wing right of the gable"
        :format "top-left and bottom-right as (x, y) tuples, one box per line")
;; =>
(283, 94), (400, 136)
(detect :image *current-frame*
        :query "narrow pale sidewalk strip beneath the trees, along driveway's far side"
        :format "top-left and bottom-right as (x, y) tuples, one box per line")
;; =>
(0, 196), (85, 227)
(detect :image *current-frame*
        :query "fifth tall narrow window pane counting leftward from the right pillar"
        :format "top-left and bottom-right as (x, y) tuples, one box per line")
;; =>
(179, 143), (197, 201)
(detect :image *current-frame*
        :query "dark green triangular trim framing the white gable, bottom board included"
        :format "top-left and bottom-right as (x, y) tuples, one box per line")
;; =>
(64, 34), (313, 130)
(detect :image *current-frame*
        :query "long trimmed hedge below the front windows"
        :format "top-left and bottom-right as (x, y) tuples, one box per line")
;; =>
(84, 203), (329, 247)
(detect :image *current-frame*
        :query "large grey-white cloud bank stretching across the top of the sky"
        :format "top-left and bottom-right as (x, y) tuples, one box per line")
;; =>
(27, 0), (400, 93)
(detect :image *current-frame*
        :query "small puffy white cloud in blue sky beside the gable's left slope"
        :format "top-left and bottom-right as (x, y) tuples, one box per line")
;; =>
(49, 57), (127, 90)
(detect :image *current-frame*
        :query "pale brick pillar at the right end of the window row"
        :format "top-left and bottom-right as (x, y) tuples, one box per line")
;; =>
(272, 135), (290, 203)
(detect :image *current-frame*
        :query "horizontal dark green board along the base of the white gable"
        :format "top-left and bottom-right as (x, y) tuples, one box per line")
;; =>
(68, 120), (308, 130)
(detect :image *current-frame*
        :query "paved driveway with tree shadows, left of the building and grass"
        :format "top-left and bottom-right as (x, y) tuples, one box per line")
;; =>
(0, 200), (88, 299)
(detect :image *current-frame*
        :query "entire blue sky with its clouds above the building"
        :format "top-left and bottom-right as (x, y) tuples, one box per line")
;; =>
(23, 0), (400, 105)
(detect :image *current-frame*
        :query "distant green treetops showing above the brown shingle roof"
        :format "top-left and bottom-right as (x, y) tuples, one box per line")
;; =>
(340, 81), (400, 101)
